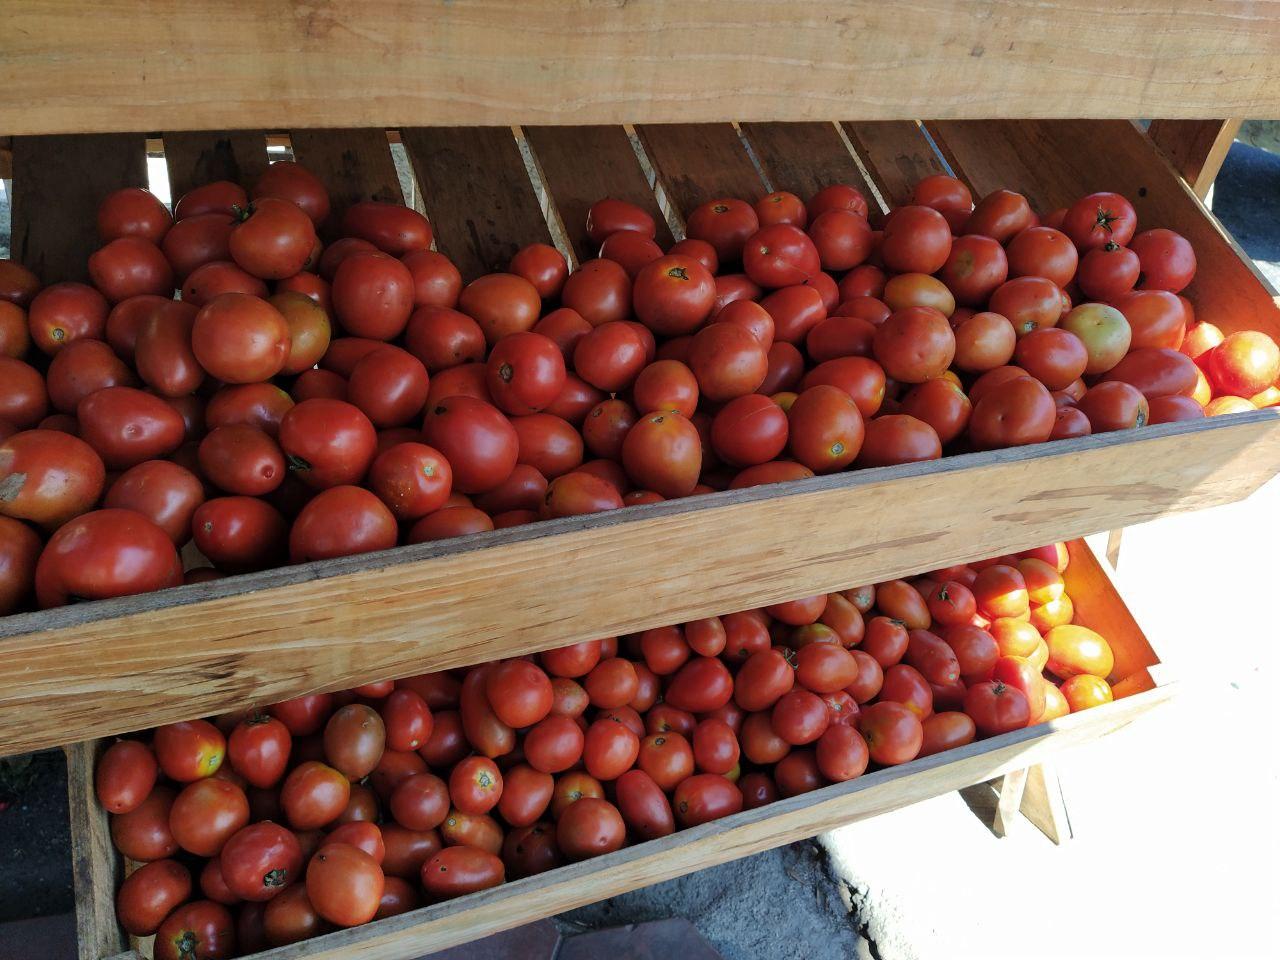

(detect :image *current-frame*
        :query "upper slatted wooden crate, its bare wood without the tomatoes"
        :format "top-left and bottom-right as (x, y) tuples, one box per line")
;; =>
(0, 120), (1280, 754)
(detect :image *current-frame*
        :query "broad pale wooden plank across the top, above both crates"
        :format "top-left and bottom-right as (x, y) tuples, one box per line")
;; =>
(10, 0), (1280, 133)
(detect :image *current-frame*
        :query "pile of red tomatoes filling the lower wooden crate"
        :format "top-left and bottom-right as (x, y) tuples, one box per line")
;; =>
(96, 544), (1114, 960)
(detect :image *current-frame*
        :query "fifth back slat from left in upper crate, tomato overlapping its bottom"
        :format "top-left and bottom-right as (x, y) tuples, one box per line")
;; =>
(524, 125), (671, 261)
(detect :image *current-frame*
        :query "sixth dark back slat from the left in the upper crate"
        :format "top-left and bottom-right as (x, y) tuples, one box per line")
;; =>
(636, 123), (765, 215)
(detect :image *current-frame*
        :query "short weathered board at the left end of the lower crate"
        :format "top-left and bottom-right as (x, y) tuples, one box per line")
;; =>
(65, 741), (125, 960)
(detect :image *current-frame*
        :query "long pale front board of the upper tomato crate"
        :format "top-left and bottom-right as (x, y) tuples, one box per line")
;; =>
(0, 410), (1280, 753)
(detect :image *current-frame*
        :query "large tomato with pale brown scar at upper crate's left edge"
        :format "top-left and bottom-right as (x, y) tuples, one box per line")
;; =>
(0, 430), (111, 530)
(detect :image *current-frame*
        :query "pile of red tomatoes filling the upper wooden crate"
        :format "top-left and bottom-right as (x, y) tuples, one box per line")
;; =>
(0, 161), (1280, 613)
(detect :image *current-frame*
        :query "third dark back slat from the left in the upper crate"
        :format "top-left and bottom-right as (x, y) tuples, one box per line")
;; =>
(289, 127), (404, 236)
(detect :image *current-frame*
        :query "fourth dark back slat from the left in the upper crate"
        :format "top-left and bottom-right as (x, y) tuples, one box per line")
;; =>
(401, 127), (552, 280)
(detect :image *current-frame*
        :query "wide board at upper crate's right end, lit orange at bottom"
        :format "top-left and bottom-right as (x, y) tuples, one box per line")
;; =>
(929, 120), (1280, 338)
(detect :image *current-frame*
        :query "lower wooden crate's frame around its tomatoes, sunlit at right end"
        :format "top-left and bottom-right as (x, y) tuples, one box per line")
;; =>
(68, 540), (1171, 960)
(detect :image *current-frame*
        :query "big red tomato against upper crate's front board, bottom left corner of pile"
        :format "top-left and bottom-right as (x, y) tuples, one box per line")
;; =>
(36, 509), (182, 607)
